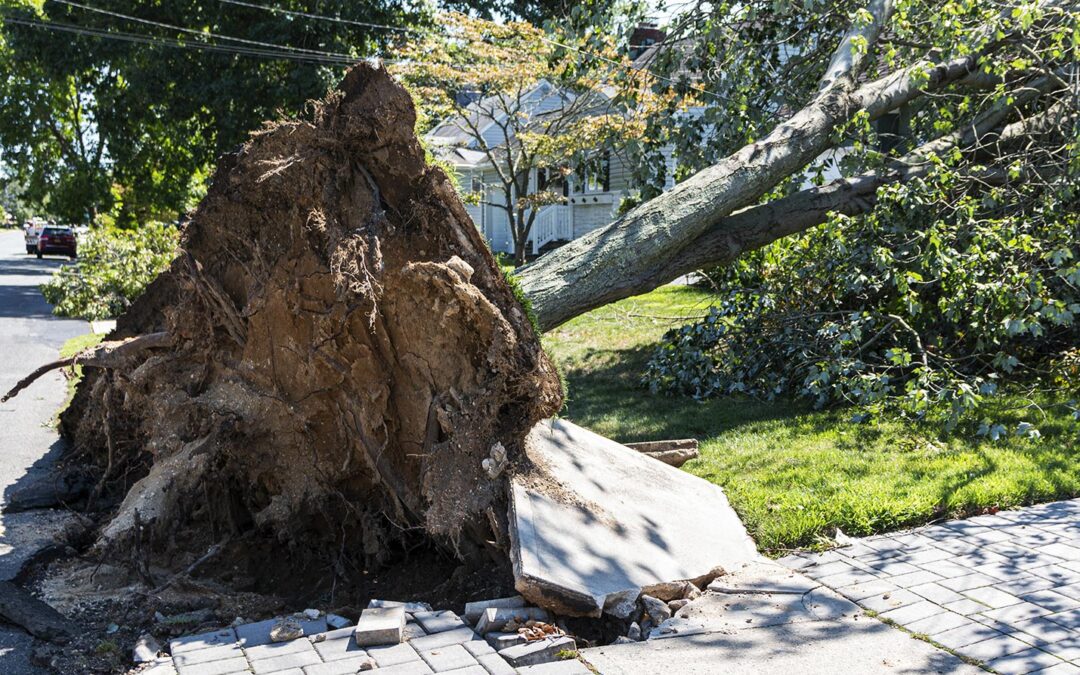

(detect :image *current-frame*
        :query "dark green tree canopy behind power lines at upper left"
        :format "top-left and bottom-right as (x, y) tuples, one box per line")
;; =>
(0, 0), (583, 224)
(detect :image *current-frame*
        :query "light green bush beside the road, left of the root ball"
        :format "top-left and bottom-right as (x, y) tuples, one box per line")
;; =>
(41, 222), (179, 321)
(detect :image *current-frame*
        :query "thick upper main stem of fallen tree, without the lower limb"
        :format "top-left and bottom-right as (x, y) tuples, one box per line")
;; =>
(518, 55), (978, 329)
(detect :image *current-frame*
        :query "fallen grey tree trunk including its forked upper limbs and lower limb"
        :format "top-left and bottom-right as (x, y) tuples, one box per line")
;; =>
(517, 1), (1075, 330)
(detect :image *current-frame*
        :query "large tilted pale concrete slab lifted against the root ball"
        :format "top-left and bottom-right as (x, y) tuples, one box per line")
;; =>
(510, 419), (759, 617)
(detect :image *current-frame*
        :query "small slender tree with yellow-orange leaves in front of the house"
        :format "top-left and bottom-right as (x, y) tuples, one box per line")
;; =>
(391, 13), (663, 264)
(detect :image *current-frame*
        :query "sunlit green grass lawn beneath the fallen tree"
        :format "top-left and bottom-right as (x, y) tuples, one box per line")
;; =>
(544, 286), (1080, 553)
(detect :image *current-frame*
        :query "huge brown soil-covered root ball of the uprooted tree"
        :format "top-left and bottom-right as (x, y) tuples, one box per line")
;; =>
(54, 65), (562, 595)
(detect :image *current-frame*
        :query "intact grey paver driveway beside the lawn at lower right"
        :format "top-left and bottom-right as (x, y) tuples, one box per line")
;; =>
(781, 499), (1080, 675)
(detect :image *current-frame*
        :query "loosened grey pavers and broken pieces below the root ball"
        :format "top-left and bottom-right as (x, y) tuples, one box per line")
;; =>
(156, 597), (590, 675)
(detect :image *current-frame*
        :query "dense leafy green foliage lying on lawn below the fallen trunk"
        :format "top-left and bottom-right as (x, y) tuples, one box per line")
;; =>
(645, 166), (1080, 440)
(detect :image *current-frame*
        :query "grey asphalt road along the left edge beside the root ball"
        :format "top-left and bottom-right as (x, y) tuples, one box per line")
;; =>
(0, 230), (90, 675)
